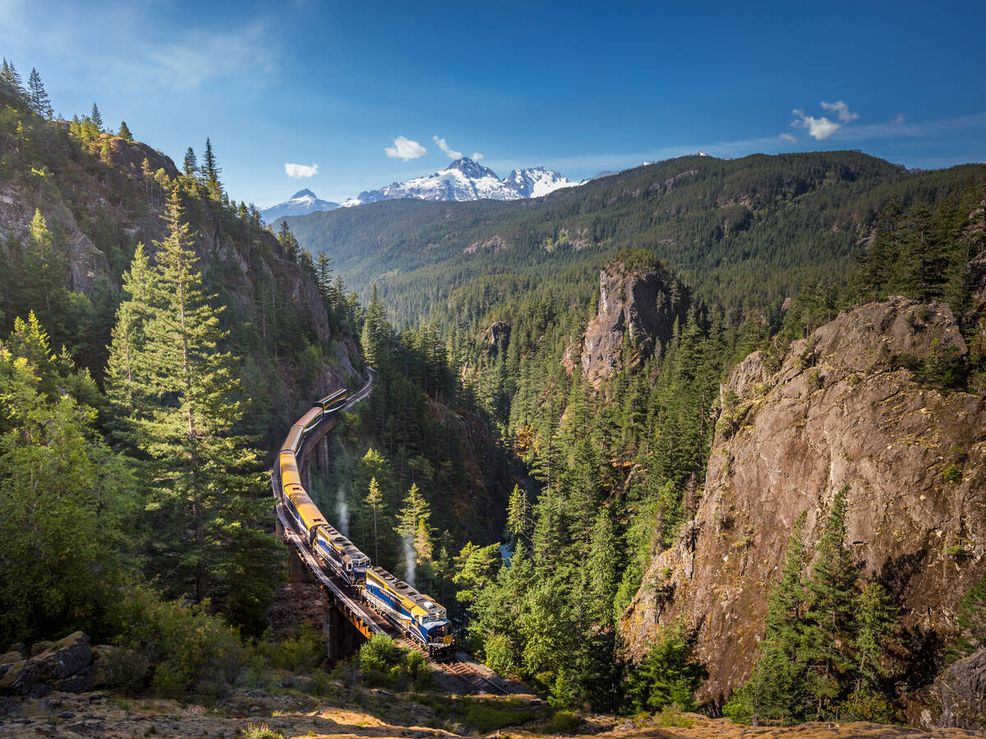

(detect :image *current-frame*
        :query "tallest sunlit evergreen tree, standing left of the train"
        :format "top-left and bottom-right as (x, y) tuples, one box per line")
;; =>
(120, 187), (278, 629)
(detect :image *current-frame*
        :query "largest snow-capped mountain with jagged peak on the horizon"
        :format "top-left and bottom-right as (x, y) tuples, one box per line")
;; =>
(342, 157), (582, 208)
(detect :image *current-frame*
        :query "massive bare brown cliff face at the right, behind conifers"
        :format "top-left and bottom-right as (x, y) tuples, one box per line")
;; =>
(621, 298), (986, 699)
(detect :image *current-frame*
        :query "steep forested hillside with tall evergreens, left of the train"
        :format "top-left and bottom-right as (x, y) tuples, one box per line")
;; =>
(0, 60), (365, 694)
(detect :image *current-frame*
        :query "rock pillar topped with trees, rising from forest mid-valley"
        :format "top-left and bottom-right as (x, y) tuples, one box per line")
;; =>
(581, 261), (688, 390)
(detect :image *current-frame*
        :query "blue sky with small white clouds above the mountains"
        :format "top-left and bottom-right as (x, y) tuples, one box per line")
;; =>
(0, 0), (986, 206)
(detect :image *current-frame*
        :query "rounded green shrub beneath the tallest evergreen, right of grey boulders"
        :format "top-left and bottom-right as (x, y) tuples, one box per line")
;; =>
(117, 588), (249, 697)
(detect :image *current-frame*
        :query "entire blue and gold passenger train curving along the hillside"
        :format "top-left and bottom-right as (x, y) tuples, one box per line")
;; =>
(276, 389), (454, 656)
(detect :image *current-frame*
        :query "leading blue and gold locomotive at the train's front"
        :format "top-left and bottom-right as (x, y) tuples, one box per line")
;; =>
(363, 567), (454, 655)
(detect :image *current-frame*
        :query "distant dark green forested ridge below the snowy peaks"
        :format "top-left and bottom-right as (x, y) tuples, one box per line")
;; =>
(288, 152), (975, 325)
